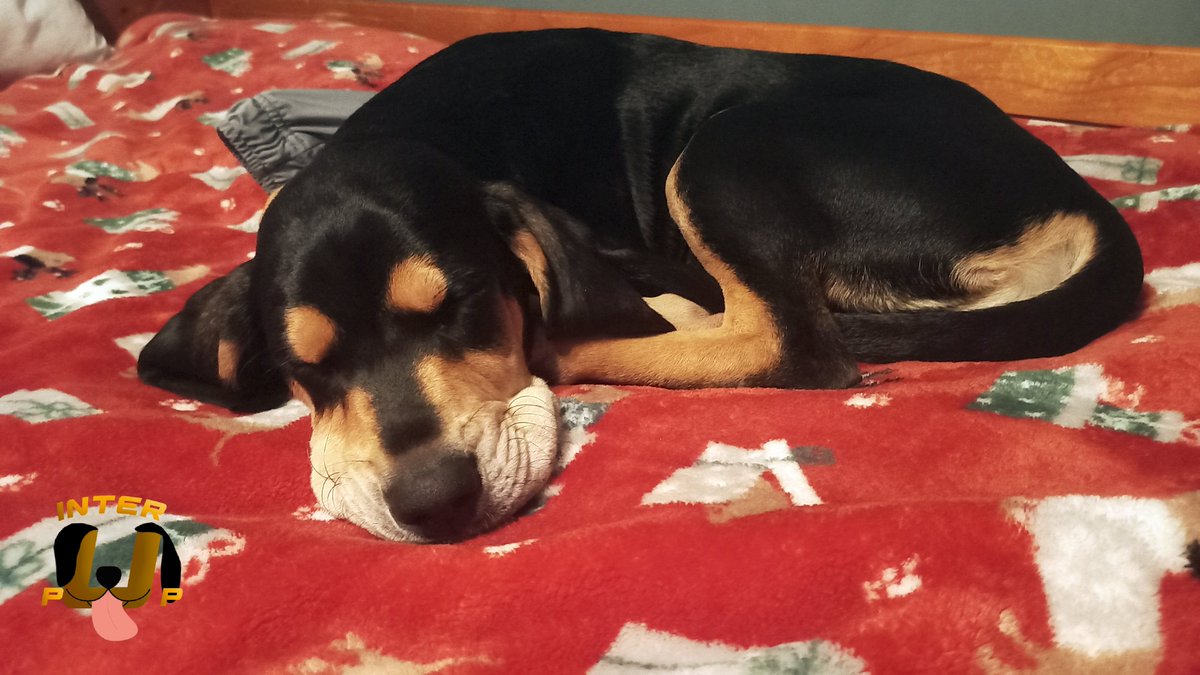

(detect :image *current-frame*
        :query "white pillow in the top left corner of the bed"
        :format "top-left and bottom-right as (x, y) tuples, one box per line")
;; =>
(0, 0), (108, 86)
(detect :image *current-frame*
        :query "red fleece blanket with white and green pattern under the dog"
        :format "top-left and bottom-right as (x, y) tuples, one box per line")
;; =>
(0, 16), (1200, 675)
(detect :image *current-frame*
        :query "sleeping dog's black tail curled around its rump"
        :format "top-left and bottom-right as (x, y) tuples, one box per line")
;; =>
(833, 204), (1142, 363)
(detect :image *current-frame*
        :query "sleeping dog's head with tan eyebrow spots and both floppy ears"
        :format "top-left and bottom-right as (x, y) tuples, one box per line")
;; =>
(138, 143), (661, 542)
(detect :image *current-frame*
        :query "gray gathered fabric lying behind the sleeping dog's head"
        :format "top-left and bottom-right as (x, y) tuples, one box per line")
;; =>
(217, 89), (374, 192)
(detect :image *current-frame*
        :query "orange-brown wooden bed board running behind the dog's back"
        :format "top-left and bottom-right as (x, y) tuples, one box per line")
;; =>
(85, 0), (1200, 126)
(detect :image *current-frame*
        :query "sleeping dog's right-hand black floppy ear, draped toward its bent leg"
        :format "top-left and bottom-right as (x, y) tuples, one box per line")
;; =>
(486, 183), (674, 339)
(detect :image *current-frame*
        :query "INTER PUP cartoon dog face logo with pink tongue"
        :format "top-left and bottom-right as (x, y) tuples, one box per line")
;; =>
(42, 495), (184, 641)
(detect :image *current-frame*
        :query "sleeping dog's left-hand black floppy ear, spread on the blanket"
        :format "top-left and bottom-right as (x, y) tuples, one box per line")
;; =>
(138, 261), (289, 412)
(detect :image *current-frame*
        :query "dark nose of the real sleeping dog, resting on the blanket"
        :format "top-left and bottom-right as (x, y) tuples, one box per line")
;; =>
(383, 453), (484, 542)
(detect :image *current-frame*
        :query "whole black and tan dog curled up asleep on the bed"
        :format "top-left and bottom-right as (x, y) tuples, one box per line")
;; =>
(138, 30), (1142, 542)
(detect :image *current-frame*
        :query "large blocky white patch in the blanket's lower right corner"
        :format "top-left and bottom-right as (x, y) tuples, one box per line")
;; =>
(1025, 496), (1187, 657)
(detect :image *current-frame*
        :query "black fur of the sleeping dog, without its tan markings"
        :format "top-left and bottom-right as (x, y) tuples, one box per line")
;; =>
(139, 30), (1142, 538)
